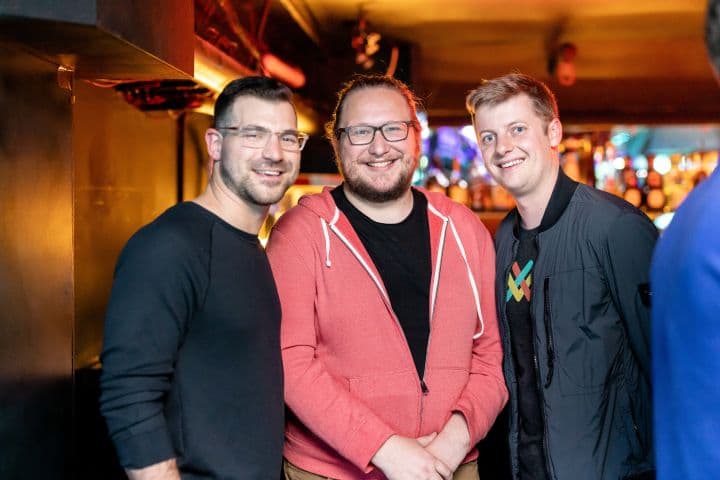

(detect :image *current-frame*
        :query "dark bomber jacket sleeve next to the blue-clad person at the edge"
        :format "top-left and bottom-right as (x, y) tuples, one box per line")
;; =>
(607, 212), (658, 381)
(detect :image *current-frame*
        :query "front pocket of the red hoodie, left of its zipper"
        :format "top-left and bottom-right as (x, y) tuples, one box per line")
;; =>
(348, 369), (421, 437)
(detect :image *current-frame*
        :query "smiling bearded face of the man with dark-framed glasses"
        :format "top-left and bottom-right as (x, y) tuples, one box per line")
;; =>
(337, 86), (420, 203)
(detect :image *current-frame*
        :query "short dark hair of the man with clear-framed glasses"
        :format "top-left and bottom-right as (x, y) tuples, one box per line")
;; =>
(213, 77), (295, 127)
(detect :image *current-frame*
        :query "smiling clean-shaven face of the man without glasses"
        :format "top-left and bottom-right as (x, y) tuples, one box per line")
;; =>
(473, 94), (562, 201)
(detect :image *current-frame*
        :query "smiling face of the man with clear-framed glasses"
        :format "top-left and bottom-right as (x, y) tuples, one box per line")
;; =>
(208, 96), (300, 207)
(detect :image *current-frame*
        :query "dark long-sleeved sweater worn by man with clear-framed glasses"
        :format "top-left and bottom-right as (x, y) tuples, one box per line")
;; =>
(101, 203), (284, 480)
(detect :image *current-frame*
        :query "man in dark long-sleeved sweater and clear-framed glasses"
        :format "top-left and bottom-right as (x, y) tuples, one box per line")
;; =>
(100, 77), (307, 480)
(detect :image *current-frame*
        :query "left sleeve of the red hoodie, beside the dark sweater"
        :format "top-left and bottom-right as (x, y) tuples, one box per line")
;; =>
(267, 225), (395, 472)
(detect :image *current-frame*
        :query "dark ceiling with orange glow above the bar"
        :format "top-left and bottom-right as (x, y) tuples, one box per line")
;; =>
(253, 0), (720, 125)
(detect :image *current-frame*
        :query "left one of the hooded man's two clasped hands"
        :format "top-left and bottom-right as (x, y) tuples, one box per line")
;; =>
(372, 434), (452, 480)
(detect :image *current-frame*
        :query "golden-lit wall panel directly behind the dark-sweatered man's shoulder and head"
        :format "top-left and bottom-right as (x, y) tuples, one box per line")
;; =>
(73, 82), (210, 368)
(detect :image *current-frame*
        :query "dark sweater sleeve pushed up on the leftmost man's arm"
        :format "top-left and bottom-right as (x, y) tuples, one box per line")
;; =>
(100, 227), (202, 468)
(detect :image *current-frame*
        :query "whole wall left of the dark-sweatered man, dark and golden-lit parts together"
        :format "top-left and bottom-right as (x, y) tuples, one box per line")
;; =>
(0, 41), (210, 480)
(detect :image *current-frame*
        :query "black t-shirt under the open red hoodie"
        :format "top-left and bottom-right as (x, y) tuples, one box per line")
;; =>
(332, 186), (431, 378)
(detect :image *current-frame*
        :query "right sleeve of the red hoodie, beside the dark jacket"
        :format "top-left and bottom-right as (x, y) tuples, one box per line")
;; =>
(454, 213), (508, 445)
